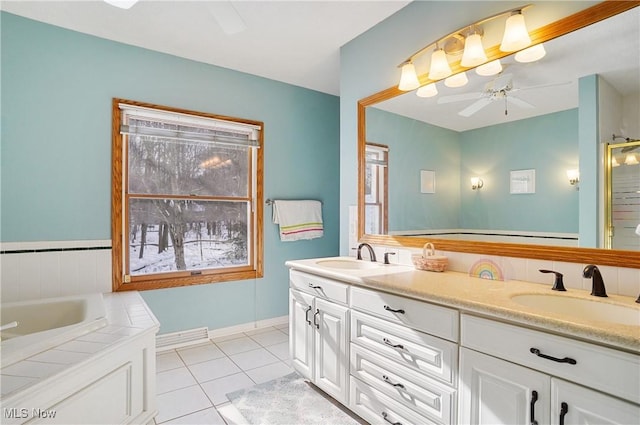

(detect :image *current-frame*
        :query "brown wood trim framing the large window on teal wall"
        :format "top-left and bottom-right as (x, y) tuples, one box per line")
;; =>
(111, 98), (264, 292)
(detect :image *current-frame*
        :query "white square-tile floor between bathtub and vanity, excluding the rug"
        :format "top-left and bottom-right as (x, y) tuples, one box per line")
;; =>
(155, 324), (293, 425)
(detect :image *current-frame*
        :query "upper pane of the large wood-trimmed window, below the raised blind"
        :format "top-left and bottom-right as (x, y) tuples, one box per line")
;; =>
(128, 135), (250, 197)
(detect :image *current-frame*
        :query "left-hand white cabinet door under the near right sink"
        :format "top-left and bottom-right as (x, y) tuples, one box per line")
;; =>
(459, 348), (551, 425)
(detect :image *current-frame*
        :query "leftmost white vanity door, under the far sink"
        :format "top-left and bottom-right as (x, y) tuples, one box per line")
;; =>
(289, 289), (315, 379)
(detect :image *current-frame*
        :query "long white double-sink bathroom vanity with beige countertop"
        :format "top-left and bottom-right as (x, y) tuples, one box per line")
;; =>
(286, 257), (640, 425)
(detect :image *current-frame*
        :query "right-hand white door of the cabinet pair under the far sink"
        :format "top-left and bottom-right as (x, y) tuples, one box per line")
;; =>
(312, 298), (348, 403)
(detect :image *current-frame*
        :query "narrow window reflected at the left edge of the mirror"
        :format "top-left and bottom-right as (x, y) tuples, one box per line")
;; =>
(364, 143), (389, 235)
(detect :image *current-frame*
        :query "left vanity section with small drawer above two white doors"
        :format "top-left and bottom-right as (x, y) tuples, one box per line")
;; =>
(289, 270), (349, 404)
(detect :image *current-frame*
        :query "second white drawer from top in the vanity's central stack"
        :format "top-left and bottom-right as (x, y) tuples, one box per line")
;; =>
(351, 311), (458, 387)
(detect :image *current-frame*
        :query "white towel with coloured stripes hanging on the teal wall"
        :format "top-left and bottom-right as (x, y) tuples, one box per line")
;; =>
(273, 201), (324, 241)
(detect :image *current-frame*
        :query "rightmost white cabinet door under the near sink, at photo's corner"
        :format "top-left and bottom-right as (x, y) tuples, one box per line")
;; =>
(551, 378), (640, 425)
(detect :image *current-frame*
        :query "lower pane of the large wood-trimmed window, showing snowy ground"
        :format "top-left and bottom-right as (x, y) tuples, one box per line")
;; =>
(128, 199), (250, 276)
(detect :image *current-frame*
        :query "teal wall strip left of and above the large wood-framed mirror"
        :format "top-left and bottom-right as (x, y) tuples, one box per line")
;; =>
(340, 1), (597, 254)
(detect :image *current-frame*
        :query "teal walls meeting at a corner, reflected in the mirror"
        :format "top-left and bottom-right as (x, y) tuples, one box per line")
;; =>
(367, 108), (579, 233)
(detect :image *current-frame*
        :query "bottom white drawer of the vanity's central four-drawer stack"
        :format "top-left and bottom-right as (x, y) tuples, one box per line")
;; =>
(349, 376), (437, 425)
